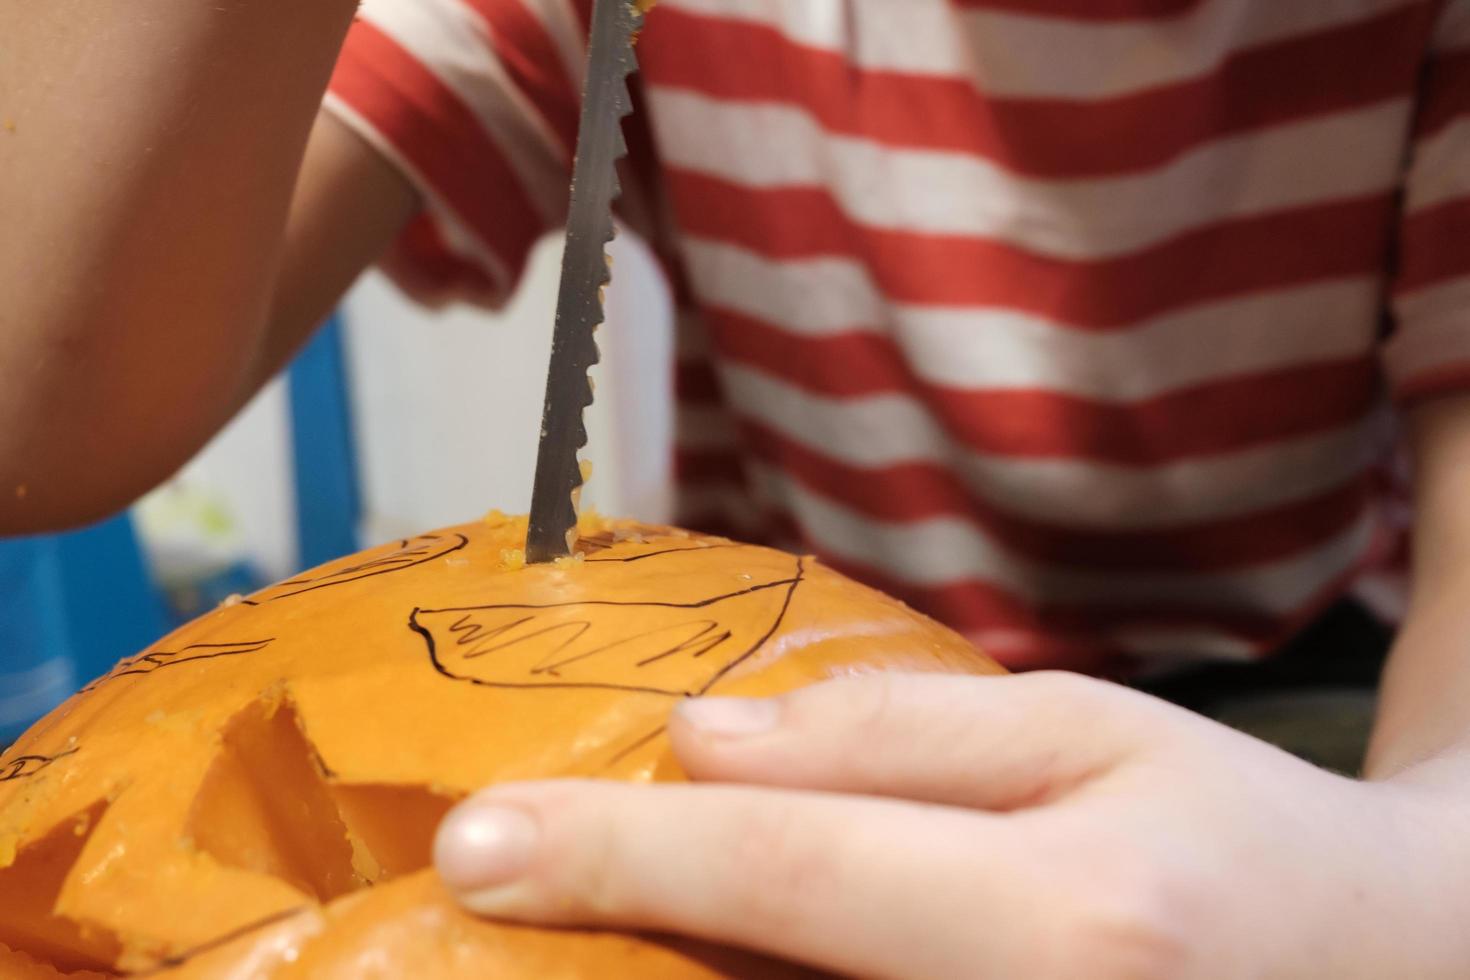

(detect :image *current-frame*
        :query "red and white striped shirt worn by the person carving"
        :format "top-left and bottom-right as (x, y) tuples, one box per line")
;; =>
(328, 0), (1470, 669)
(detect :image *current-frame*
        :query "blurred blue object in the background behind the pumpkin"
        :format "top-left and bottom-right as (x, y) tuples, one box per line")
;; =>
(0, 317), (362, 746)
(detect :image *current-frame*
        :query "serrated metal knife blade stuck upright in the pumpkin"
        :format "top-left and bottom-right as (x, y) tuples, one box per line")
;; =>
(526, 0), (650, 563)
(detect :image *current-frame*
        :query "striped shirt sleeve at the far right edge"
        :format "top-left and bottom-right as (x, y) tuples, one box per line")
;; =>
(1385, 0), (1470, 404)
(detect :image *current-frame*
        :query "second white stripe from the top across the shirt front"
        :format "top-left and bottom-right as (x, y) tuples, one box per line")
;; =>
(650, 85), (1410, 259)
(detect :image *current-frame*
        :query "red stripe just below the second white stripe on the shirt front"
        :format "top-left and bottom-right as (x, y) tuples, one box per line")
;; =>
(669, 174), (1395, 329)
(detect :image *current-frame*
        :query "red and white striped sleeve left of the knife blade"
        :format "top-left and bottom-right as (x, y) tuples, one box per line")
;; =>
(325, 0), (587, 306)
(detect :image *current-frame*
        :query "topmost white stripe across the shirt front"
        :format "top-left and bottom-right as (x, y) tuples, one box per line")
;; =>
(662, 0), (1421, 100)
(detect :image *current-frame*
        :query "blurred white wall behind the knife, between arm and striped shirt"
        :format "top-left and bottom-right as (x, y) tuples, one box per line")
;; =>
(140, 235), (672, 577)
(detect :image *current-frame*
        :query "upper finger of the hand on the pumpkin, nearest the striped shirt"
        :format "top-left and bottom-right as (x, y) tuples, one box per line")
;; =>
(669, 673), (1185, 810)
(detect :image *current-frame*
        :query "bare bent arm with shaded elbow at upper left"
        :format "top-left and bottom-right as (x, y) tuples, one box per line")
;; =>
(0, 0), (417, 533)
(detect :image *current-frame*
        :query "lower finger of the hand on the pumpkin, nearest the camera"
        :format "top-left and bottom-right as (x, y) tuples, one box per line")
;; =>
(435, 782), (1060, 977)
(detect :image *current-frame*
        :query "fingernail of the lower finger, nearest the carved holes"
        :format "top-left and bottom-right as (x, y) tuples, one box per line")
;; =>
(434, 801), (541, 893)
